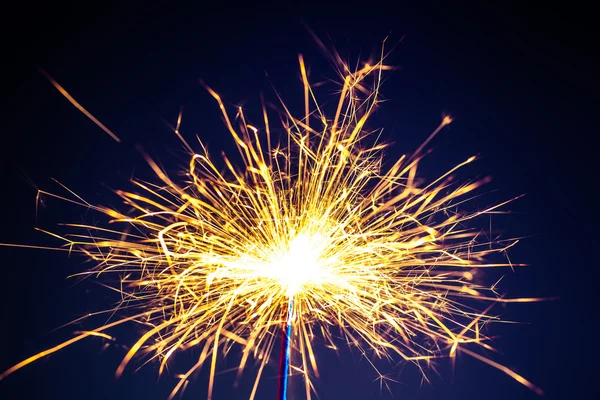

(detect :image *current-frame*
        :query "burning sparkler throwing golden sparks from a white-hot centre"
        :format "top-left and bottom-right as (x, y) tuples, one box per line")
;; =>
(0, 41), (541, 399)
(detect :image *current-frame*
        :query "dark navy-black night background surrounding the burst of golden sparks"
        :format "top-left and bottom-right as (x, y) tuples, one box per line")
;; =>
(0, 1), (598, 400)
